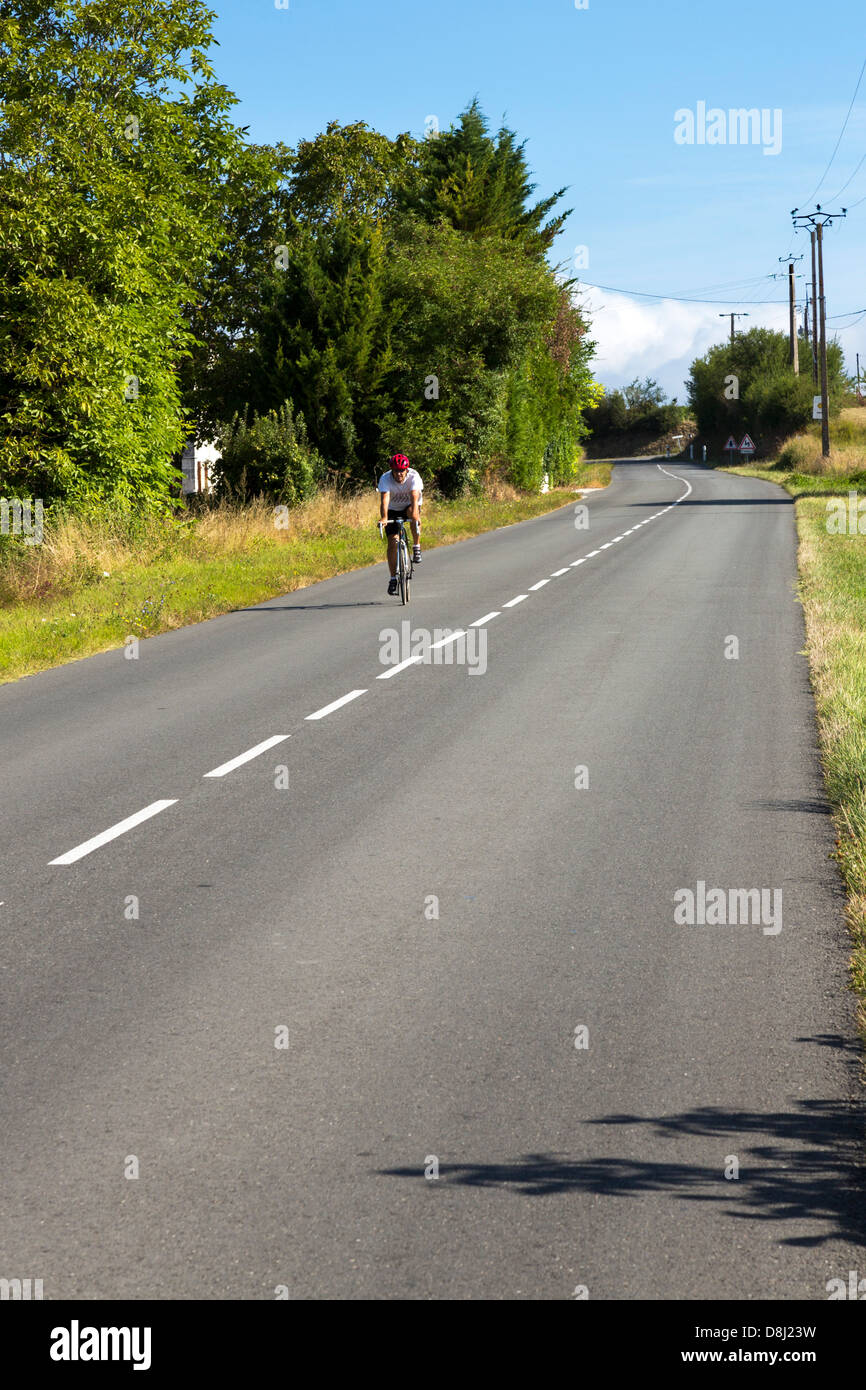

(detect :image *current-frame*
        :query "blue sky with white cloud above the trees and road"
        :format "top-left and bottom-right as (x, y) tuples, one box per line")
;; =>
(211, 0), (866, 399)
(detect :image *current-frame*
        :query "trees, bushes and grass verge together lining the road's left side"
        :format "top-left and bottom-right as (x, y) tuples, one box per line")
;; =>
(0, 0), (609, 678)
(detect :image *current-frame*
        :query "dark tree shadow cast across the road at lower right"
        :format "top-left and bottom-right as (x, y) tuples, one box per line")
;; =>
(384, 1106), (866, 1247)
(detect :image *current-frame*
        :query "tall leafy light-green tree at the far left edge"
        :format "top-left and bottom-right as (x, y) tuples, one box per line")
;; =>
(0, 0), (252, 505)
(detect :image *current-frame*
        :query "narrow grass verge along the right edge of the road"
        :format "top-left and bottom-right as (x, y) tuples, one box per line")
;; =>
(726, 455), (866, 1043)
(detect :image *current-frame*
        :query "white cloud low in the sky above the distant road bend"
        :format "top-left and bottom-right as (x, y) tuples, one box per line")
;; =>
(580, 289), (788, 404)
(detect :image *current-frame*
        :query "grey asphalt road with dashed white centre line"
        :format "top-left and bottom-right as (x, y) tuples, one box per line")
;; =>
(0, 461), (866, 1300)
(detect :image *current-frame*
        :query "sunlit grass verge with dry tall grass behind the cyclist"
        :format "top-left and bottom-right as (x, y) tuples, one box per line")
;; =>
(0, 464), (610, 682)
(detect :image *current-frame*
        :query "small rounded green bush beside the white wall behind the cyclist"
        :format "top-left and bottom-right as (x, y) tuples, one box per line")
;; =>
(217, 400), (322, 506)
